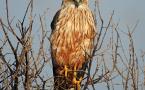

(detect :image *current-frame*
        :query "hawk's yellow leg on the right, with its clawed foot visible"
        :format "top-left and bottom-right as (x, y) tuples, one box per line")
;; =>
(73, 64), (82, 90)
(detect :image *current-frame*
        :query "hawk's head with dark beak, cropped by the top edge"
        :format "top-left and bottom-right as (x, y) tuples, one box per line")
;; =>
(63, 0), (88, 7)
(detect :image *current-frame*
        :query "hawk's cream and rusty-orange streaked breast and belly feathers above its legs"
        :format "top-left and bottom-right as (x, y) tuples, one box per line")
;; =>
(51, 8), (95, 68)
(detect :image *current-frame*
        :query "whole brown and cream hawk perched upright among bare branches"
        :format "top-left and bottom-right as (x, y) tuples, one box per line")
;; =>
(50, 0), (96, 90)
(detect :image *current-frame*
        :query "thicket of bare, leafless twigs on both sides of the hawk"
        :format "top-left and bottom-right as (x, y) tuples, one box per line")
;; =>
(0, 0), (145, 90)
